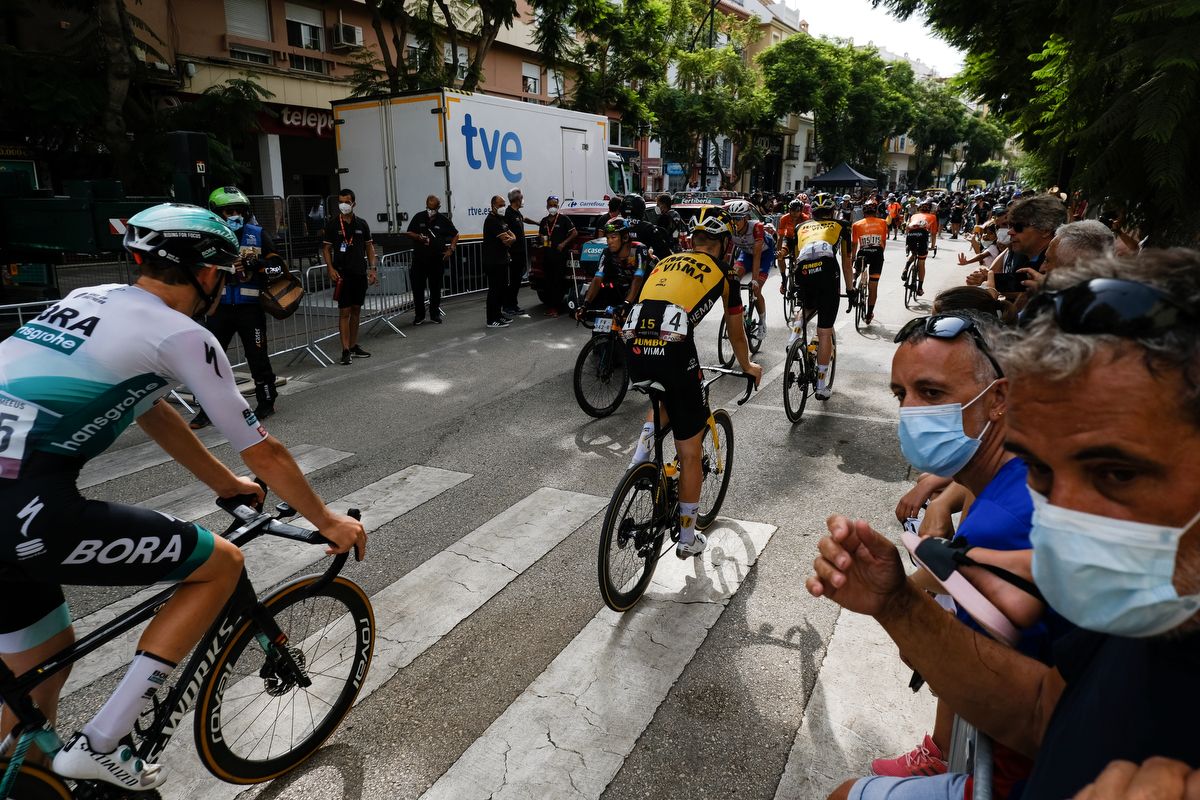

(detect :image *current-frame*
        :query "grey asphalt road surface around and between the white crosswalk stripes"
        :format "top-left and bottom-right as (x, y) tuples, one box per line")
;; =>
(51, 227), (966, 800)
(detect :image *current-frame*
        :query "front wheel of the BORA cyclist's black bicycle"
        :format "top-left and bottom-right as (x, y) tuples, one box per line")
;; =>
(196, 576), (374, 783)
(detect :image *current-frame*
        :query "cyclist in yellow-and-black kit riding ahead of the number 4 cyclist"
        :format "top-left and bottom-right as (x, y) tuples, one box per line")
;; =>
(780, 192), (854, 401)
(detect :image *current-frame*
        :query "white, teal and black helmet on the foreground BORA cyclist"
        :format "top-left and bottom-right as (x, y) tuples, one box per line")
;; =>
(125, 203), (240, 272)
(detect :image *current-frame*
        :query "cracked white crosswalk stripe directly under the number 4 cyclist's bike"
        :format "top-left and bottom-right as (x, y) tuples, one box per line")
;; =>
(422, 521), (775, 800)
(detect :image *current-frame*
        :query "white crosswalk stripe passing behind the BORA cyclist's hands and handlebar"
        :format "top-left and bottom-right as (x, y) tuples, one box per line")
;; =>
(62, 462), (470, 697)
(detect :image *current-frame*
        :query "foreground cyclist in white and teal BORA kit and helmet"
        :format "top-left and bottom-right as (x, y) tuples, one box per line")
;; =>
(0, 204), (366, 790)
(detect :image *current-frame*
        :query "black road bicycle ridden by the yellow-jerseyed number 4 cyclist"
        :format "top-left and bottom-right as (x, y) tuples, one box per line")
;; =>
(598, 367), (755, 612)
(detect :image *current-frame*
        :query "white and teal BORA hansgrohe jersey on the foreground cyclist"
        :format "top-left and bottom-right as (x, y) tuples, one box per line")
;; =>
(0, 284), (266, 482)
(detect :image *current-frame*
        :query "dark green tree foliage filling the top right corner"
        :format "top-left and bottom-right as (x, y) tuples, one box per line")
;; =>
(876, 0), (1200, 246)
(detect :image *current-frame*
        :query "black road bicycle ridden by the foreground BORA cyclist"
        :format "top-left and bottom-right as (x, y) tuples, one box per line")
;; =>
(0, 497), (376, 800)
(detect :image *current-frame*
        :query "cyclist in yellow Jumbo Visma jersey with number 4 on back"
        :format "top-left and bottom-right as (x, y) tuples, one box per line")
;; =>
(622, 209), (762, 559)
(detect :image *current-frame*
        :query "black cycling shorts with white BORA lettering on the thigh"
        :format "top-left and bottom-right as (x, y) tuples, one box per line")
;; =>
(0, 476), (215, 652)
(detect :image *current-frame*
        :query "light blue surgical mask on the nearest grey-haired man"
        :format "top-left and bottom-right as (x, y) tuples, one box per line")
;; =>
(1030, 489), (1200, 637)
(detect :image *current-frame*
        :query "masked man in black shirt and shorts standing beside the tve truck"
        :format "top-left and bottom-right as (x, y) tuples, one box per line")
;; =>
(322, 188), (379, 366)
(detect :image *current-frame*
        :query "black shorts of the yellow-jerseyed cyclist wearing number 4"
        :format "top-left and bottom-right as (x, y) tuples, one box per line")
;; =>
(626, 336), (709, 441)
